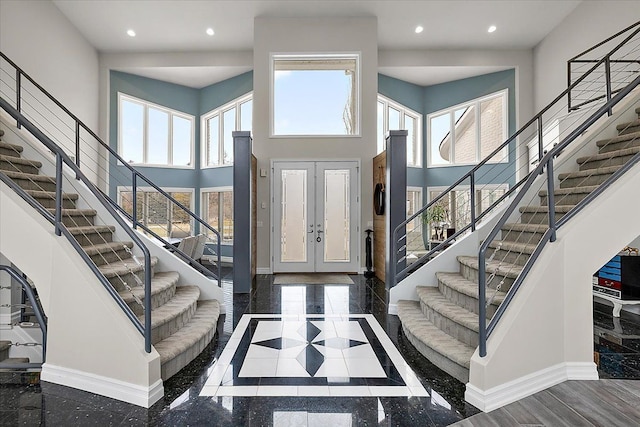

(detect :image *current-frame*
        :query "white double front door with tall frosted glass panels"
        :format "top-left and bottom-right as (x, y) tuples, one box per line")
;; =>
(273, 161), (360, 273)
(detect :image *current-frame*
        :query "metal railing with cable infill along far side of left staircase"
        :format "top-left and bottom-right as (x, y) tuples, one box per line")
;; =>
(0, 52), (222, 287)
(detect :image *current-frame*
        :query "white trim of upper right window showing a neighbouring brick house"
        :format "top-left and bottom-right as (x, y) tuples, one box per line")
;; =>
(426, 89), (509, 168)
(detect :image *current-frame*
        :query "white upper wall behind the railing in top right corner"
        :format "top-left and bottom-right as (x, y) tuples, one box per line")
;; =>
(533, 0), (640, 111)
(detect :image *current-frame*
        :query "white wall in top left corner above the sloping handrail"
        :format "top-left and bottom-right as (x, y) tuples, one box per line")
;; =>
(0, 0), (98, 130)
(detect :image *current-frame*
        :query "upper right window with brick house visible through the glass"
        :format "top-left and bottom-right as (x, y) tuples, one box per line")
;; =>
(427, 90), (509, 166)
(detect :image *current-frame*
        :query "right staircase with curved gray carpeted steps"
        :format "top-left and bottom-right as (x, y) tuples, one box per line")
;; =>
(398, 108), (640, 383)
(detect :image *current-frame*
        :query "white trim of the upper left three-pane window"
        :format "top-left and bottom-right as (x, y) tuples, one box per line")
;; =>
(117, 92), (196, 169)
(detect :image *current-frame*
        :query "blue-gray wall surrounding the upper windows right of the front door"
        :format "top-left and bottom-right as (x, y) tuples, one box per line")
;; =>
(378, 69), (516, 194)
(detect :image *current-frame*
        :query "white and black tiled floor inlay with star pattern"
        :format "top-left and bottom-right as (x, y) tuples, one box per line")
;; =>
(200, 314), (429, 396)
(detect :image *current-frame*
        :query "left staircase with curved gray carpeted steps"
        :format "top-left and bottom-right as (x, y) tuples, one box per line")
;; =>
(0, 129), (220, 380)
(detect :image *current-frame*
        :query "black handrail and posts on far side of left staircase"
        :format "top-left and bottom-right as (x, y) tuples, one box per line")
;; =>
(0, 51), (222, 287)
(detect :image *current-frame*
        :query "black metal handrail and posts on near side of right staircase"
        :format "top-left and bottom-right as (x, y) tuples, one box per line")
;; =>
(478, 77), (640, 357)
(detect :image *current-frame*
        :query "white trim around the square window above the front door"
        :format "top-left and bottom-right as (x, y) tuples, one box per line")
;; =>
(269, 51), (362, 139)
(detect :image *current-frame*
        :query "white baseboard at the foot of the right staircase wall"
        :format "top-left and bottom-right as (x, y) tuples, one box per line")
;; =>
(464, 362), (598, 412)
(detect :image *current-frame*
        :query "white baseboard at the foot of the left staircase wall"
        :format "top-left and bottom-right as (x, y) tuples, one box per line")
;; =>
(40, 363), (164, 408)
